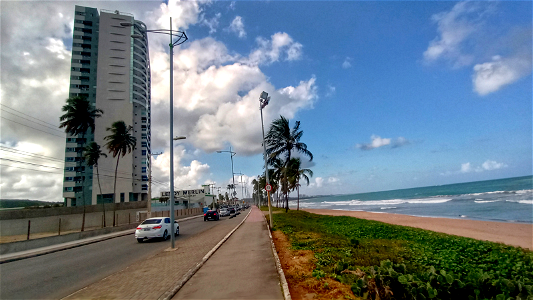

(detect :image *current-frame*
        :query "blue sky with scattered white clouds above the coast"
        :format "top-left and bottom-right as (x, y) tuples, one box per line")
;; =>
(0, 1), (533, 201)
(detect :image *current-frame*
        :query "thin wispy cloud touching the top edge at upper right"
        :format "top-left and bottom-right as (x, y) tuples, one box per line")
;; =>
(423, 1), (491, 67)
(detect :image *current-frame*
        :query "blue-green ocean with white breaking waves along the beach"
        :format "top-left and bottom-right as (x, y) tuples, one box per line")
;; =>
(289, 176), (533, 223)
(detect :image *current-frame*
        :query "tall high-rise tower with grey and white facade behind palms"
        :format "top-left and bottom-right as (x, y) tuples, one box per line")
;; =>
(63, 6), (151, 206)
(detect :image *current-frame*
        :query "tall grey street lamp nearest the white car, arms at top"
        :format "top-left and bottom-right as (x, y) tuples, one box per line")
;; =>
(120, 17), (188, 248)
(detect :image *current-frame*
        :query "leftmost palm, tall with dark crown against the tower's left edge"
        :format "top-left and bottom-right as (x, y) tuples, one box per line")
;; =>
(59, 96), (104, 231)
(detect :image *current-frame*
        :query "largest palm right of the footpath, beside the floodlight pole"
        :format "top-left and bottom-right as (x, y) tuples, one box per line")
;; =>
(265, 116), (313, 212)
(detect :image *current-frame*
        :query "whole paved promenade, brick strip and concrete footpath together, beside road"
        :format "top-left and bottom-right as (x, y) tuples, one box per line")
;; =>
(64, 207), (283, 299)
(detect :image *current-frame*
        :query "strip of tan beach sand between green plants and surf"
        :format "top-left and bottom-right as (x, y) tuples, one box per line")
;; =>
(303, 209), (533, 250)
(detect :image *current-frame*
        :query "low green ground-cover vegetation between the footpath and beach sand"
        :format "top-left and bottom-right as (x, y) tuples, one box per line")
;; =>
(273, 211), (533, 299)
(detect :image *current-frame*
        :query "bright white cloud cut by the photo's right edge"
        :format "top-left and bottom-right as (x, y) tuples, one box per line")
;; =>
(472, 55), (531, 96)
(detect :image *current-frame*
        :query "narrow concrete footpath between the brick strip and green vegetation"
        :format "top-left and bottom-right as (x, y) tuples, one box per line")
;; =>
(172, 206), (283, 300)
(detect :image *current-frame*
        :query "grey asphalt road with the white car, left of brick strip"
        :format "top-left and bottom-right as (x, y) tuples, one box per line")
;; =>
(0, 217), (237, 299)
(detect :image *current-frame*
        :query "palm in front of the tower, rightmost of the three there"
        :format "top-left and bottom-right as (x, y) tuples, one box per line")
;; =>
(104, 121), (137, 226)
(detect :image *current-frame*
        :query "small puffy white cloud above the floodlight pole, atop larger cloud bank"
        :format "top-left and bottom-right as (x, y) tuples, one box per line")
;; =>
(242, 32), (303, 66)
